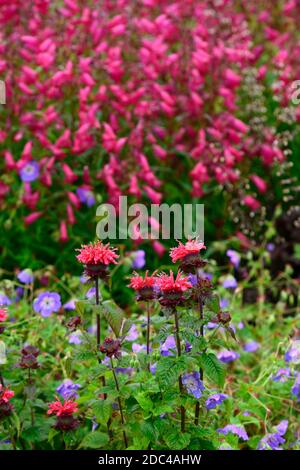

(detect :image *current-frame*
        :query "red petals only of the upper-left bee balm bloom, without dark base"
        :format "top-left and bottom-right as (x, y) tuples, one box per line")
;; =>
(76, 240), (119, 266)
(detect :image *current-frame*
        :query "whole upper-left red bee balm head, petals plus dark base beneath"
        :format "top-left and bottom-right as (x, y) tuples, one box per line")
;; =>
(76, 240), (119, 278)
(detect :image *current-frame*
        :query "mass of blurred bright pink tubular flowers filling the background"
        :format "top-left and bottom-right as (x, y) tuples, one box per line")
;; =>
(0, 0), (299, 246)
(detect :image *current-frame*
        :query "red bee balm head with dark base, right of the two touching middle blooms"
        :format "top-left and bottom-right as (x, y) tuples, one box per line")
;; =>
(156, 271), (192, 307)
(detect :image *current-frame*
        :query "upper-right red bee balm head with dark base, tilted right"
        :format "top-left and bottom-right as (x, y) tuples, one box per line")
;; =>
(170, 239), (206, 273)
